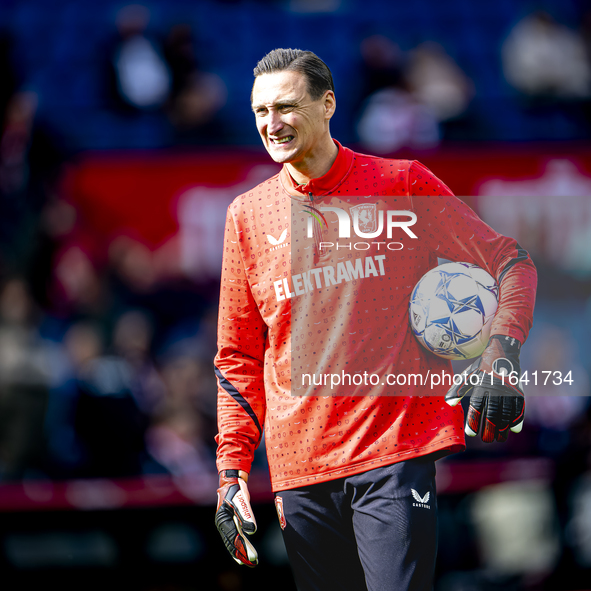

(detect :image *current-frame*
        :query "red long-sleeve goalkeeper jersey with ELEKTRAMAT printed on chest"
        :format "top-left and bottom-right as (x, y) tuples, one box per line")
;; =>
(215, 142), (536, 491)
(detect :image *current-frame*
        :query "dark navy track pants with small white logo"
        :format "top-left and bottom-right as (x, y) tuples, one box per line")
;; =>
(276, 456), (437, 591)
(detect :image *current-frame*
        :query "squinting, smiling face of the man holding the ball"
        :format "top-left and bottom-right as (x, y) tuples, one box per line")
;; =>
(252, 70), (337, 182)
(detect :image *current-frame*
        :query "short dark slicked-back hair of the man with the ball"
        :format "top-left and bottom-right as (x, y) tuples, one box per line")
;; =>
(253, 49), (334, 101)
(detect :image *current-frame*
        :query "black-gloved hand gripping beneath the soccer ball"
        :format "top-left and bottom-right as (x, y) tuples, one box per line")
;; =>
(445, 335), (525, 443)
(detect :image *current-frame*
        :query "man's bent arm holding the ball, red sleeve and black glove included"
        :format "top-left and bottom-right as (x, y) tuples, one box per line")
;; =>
(409, 162), (537, 442)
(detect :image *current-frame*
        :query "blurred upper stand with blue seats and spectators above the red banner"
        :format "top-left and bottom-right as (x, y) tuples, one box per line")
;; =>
(0, 0), (591, 153)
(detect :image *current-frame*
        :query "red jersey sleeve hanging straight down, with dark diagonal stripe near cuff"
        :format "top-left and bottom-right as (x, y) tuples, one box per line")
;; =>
(214, 205), (267, 472)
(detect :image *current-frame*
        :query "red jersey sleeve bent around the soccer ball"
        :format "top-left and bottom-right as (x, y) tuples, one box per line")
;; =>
(408, 161), (537, 343)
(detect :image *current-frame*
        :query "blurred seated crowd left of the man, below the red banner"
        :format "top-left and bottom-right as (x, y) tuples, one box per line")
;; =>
(0, 277), (216, 482)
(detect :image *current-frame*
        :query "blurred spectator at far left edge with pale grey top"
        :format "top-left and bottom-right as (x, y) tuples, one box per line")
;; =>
(0, 278), (50, 480)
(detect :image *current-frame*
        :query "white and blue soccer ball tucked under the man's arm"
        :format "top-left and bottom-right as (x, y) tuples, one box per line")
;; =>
(410, 263), (499, 360)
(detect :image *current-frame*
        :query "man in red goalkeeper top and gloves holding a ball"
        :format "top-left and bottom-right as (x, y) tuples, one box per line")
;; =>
(215, 49), (536, 591)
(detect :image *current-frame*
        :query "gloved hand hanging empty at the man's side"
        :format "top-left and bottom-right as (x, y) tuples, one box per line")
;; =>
(215, 470), (259, 567)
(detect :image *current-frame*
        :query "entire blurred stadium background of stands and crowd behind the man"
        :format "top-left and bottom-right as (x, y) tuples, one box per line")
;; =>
(0, 0), (591, 591)
